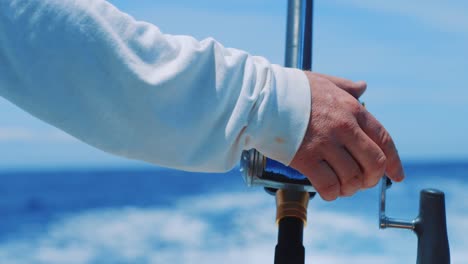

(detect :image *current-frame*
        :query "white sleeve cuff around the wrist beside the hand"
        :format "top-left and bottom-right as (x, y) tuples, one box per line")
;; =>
(250, 65), (312, 165)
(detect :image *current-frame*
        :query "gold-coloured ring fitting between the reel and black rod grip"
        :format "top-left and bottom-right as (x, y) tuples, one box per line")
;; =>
(276, 189), (310, 226)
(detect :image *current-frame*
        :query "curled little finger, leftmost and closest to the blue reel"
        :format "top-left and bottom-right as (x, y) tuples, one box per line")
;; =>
(305, 160), (340, 201)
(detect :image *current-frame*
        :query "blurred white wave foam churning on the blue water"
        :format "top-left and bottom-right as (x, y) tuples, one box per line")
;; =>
(0, 184), (468, 264)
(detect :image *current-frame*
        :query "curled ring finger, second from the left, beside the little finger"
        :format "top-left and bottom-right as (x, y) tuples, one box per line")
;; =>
(325, 146), (363, 196)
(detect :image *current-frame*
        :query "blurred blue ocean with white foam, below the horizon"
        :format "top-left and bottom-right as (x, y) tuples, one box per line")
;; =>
(0, 162), (468, 264)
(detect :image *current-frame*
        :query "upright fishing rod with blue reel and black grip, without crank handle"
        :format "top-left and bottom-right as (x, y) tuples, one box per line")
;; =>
(241, 0), (315, 264)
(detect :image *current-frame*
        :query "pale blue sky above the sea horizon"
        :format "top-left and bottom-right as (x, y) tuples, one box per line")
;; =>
(0, 0), (468, 168)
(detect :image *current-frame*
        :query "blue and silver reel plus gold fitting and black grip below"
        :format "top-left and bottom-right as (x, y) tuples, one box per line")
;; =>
(240, 149), (315, 264)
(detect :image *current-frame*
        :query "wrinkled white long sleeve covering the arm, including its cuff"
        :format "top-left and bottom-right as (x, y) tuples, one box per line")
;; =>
(0, 0), (311, 172)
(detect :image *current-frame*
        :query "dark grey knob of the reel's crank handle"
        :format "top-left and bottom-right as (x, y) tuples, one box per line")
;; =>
(415, 189), (450, 264)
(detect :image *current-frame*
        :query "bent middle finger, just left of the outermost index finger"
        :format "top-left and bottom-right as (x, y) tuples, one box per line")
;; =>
(340, 120), (386, 188)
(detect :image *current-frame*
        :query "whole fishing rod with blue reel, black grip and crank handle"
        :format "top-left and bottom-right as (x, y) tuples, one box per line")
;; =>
(240, 0), (450, 264)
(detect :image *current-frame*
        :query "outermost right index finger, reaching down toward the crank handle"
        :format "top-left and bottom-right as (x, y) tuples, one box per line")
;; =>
(358, 111), (405, 182)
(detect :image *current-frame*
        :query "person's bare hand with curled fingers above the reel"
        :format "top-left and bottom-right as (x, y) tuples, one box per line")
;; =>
(290, 72), (404, 201)
